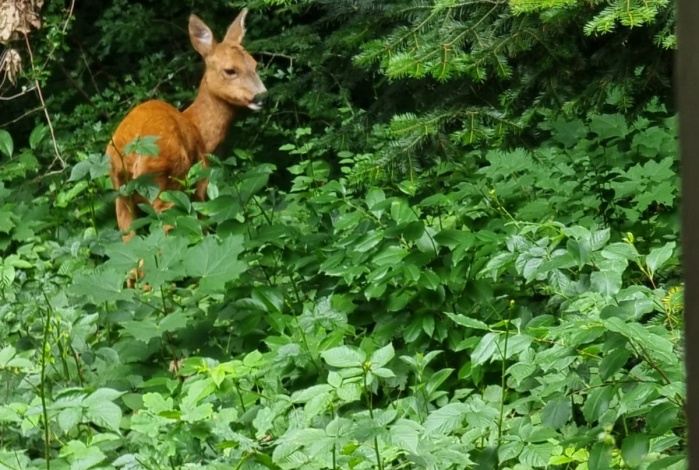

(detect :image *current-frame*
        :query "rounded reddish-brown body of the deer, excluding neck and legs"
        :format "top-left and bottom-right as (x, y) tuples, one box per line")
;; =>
(107, 100), (204, 188)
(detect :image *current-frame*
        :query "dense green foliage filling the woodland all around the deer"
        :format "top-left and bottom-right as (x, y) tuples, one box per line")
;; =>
(0, 0), (686, 470)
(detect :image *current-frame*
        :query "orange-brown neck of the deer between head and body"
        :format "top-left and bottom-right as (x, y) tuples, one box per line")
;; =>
(182, 80), (235, 153)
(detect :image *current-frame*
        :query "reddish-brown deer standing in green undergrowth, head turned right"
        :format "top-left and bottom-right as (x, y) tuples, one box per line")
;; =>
(107, 8), (267, 244)
